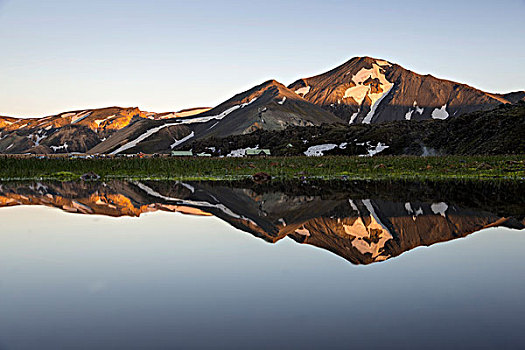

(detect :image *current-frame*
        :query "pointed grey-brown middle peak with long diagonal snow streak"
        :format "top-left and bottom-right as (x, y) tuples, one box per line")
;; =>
(89, 80), (342, 154)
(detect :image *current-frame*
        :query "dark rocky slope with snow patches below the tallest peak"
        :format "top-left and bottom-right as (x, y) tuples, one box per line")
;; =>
(186, 102), (525, 156)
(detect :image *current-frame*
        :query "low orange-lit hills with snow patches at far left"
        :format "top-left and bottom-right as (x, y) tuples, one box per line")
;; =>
(0, 107), (210, 154)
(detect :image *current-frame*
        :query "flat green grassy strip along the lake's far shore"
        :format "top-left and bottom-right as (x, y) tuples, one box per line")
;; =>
(0, 155), (525, 180)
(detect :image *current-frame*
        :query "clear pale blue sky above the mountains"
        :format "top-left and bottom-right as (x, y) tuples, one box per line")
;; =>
(0, 0), (525, 116)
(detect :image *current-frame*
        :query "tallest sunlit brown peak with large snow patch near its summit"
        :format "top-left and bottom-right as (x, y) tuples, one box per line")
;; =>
(289, 57), (525, 124)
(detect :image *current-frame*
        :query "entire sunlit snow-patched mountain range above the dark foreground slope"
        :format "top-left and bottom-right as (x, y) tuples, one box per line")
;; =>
(0, 56), (525, 154)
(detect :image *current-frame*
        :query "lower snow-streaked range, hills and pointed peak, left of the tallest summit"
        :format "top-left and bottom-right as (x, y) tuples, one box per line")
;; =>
(0, 80), (342, 154)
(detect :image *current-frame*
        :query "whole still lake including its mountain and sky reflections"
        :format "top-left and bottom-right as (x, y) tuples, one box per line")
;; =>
(0, 180), (525, 349)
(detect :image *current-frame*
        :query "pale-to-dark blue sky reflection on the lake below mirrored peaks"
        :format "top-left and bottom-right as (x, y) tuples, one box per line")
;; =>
(0, 207), (525, 349)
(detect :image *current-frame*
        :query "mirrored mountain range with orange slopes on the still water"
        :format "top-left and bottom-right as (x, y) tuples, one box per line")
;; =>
(0, 181), (525, 264)
